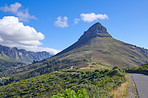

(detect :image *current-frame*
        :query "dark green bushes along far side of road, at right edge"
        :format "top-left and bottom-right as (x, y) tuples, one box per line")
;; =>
(125, 64), (148, 75)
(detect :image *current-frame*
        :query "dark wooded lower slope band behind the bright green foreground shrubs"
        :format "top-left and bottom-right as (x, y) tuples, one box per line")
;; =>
(0, 59), (87, 86)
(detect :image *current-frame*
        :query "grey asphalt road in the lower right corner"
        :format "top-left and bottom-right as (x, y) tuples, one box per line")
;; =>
(131, 74), (148, 98)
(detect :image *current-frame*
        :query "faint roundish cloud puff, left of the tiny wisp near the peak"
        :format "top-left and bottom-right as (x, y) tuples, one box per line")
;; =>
(54, 16), (68, 28)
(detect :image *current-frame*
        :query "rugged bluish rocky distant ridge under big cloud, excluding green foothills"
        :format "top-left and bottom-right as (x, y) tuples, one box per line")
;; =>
(0, 45), (52, 64)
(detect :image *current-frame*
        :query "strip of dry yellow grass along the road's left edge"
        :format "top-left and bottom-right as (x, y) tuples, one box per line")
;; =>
(111, 76), (129, 98)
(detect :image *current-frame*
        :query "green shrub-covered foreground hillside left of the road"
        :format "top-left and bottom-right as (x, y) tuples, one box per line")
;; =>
(0, 67), (125, 98)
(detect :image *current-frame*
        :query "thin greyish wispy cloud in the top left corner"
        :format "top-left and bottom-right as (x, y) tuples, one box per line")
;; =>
(0, 2), (37, 21)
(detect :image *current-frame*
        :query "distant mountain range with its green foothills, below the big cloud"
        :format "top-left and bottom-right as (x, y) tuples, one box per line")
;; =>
(0, 45), (52, 72)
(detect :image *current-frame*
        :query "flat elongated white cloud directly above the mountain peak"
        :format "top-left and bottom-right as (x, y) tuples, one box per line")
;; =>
(80, 13), (108, 22)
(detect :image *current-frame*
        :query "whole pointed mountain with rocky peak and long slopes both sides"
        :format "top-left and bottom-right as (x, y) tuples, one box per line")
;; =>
(6, 23), (148, 79)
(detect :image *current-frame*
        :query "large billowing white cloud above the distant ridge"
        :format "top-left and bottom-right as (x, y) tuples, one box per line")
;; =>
(0, 16), (59, 54)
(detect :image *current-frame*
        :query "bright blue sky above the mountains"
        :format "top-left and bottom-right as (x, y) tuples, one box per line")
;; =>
(0, 0), (148, 54)
